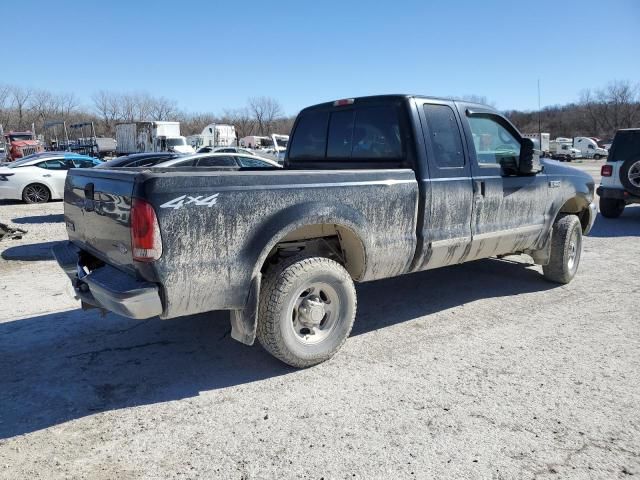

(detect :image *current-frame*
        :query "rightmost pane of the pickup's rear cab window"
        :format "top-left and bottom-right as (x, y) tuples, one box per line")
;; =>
(351, 106), (402, 159)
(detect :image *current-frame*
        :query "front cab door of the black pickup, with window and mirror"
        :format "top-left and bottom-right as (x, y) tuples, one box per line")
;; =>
(461, 107), (549, 260)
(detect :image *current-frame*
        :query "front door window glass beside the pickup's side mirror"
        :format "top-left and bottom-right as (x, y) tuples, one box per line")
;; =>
(468, 115), (520, 165)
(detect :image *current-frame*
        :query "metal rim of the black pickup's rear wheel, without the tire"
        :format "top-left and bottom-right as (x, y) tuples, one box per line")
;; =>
(289, 282), (340, 345)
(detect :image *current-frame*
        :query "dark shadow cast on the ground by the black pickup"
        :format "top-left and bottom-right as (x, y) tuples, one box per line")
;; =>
(0, 260), (553, 438)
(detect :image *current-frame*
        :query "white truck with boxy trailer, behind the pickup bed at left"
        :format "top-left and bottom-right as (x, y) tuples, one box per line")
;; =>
(116, 121), (194, 155)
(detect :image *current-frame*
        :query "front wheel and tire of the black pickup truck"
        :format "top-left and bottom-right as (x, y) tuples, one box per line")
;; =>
(542, 215), (582, 284)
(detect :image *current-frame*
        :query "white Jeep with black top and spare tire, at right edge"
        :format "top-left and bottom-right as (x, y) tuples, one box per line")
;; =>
(598, 128), (640, 218)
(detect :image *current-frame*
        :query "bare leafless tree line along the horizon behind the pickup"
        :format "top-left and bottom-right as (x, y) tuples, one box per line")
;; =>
(0, 81), (640, 142)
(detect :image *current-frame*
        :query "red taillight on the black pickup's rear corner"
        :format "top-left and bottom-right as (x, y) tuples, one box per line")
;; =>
(131, 198), (162, 262)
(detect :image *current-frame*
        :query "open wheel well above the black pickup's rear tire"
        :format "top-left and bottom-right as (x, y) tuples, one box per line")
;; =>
(261, 223), (366, 280)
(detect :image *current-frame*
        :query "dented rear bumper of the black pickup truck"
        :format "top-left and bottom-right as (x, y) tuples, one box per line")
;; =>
(52, 242), (162, 319)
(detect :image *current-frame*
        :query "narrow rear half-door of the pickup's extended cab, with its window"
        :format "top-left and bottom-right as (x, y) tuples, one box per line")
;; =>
(413, 99), (473, 271)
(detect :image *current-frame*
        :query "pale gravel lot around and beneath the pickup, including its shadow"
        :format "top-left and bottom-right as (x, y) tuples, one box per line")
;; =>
(0, 162), (640, 479)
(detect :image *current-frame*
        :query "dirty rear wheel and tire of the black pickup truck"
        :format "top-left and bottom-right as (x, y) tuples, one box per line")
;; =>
(256, 256), (357, 368)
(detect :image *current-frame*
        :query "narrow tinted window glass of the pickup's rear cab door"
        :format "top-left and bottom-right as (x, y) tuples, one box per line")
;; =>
(424, 104), (464, 168)
